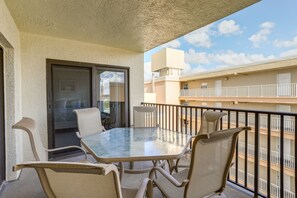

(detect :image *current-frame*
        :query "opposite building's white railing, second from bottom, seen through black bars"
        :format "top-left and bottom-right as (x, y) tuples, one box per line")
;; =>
(238, 142), (295, 169)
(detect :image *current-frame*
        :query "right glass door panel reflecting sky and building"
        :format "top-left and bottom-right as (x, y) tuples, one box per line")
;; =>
(96, 68), (129, 129)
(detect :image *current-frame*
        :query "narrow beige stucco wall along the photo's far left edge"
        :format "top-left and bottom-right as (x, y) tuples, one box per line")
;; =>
(0, 0), (22, 180)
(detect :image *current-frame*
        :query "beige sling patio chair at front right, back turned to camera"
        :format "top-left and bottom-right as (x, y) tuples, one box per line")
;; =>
(150, 127), (250, 198)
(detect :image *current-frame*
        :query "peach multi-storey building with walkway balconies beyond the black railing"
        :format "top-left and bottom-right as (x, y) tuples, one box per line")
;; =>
(145, 49), (297, 197)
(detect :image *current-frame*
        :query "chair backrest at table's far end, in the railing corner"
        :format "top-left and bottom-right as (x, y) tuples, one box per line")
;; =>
(133, 106), (158, 127)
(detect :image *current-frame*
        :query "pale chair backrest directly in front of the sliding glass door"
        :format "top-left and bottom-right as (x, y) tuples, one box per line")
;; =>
(73, 107), (105, 137)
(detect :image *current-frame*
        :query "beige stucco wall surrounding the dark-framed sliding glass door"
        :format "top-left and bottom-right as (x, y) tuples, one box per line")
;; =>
(21, 33), (144, 160)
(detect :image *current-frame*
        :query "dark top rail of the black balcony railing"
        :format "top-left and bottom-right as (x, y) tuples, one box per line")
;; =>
(141, 102), (297, 116)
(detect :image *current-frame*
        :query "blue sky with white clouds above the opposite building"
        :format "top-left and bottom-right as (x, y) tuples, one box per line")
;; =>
(144, 0), (297, 80)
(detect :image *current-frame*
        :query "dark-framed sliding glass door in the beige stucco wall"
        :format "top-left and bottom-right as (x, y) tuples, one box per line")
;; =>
(47, 60), (129, 157)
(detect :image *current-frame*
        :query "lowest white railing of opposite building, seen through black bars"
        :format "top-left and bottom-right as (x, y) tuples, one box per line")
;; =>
(230, 167), (295, 198)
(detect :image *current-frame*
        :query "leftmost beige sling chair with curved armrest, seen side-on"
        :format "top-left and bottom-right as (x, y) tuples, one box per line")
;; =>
(12, 117), (87, 161)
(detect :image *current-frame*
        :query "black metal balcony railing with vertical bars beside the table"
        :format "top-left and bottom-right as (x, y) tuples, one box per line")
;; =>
(142, 103), (297, 198)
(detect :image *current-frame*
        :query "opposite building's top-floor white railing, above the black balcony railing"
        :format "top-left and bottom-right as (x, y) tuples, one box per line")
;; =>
(180, 83), (297, 97)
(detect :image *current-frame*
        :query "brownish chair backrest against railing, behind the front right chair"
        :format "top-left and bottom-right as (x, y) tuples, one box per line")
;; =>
(198, 110), (227, 135)
